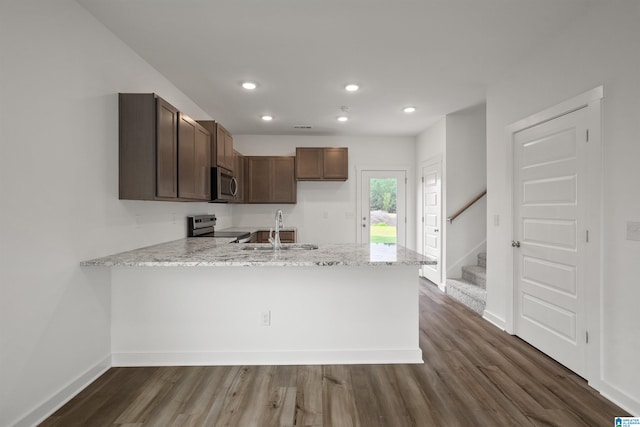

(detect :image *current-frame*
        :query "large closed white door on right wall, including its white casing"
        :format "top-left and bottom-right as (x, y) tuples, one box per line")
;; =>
(508, 87), (602, 379)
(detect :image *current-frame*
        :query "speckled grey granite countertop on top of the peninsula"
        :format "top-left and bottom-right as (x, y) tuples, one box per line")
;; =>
(80, 237), (436, 267)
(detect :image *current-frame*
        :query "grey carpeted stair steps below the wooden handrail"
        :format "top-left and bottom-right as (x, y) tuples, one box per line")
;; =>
(446, 252), (487, 315)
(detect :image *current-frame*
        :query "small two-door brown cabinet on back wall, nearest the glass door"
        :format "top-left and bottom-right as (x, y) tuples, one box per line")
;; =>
(296, 147), (349, 181)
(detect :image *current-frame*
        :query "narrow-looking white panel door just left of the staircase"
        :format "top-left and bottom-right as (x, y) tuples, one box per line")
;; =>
(421, 162), (442, 285)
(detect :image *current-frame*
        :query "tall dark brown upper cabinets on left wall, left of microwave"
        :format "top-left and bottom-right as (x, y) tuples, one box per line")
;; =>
(118, 93), (211, 201)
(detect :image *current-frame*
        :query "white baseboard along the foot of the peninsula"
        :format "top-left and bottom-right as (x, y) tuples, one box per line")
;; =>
(112, 348), (423, 367)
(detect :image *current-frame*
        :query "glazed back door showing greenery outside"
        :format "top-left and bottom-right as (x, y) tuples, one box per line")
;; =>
(358, 170), (407, 246)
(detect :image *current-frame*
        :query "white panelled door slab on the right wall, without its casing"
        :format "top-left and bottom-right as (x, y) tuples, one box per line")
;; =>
(512, 108), (588, 376)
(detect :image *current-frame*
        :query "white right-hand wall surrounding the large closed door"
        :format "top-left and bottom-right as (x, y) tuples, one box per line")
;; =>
(487, 0), (640, 415)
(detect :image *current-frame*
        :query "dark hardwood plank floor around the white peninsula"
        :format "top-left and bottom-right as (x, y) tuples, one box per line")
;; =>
(42, 281), (629, 427)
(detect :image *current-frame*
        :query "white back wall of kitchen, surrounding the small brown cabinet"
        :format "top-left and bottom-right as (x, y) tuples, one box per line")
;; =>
(233, 135), (415, 249)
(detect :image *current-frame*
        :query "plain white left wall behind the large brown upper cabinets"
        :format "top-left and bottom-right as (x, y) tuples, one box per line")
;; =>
(0, 0), (231, 426)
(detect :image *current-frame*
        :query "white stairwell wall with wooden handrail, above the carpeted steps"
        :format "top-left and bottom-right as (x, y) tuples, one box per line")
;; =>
(442, 104), (487, 278)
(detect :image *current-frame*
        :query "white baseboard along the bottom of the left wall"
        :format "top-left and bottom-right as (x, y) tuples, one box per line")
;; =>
(12, 355), (111, 427)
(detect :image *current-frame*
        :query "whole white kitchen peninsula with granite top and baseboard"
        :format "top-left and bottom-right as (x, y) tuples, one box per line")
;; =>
(82, 238), (435, 366)
